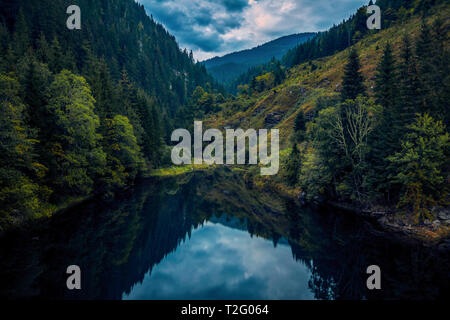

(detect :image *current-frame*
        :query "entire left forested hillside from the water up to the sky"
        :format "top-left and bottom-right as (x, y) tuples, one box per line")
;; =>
(0, 0), (220, 230)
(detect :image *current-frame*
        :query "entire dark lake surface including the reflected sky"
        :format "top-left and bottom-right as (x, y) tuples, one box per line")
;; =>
(0, 172), (450, 300)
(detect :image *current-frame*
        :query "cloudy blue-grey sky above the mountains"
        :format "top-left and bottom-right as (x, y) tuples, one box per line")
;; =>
(137, 0), (369, 60)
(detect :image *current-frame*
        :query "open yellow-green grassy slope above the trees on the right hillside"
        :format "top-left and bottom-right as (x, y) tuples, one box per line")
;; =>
(205, 6), (450, 149)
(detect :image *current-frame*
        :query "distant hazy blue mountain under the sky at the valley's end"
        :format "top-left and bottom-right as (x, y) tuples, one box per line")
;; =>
(202, 33), (316, 83)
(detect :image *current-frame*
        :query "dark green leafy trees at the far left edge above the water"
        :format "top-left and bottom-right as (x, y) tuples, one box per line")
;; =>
(0, 75), (48, 230)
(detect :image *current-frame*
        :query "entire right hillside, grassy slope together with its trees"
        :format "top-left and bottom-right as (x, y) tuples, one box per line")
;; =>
(208, 0), (450, 224)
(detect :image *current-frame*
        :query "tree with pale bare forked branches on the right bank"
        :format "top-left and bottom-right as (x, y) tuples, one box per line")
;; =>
(307, 96), (382, 201)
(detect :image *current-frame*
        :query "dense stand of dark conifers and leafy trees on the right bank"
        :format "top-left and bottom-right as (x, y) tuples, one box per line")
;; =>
(286, 7), (450, 223)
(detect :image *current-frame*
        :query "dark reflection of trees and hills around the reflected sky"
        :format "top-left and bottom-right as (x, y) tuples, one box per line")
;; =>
(0, 171), (449, 299)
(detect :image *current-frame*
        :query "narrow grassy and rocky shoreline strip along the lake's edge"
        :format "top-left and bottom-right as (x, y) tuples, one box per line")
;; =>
(0, 165), (450, 250)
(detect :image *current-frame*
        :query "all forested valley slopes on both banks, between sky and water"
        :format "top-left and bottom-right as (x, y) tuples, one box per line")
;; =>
(0, 0), (450, 235)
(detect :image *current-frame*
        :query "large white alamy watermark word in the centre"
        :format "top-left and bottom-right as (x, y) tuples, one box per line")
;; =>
(172, 121), (280, 176)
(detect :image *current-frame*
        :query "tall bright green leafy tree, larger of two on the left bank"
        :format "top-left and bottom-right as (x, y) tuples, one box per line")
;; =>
(42, 70), (106, 195)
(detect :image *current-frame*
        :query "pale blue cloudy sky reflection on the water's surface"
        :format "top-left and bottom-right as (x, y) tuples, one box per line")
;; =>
(122, 222), (314, 300)
